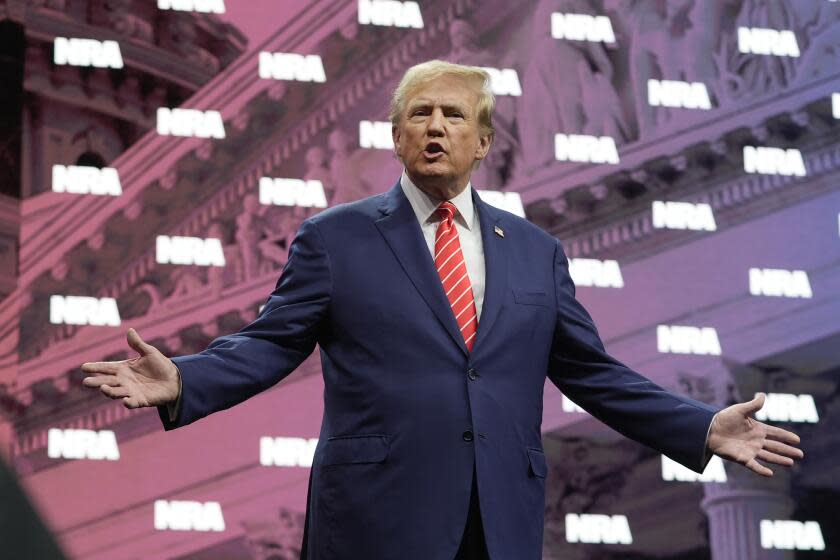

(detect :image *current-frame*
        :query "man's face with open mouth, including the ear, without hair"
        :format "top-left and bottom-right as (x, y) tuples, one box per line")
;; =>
(393, 76), (491, 199)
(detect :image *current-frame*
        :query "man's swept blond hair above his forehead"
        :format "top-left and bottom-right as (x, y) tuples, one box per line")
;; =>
(388, 60), (496, 136)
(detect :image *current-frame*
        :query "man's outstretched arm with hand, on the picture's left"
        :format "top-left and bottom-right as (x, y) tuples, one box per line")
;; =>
(77, 220), (332, 430)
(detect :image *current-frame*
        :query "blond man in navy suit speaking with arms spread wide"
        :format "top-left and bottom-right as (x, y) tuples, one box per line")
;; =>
(82, 61), (802, 560)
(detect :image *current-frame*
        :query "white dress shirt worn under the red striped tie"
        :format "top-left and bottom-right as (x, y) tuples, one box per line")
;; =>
(400, 170), (484, 320)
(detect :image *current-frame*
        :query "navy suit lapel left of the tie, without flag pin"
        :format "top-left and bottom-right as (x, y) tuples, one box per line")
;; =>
(375, 182), (472, 354)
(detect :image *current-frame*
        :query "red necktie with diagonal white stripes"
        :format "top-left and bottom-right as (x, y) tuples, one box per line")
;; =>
(435, 201), (478, 351)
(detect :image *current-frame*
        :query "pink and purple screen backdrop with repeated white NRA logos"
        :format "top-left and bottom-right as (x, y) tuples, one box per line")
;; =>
(0, 0), (840, 560)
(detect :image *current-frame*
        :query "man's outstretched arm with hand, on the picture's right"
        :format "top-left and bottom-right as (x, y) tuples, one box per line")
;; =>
(549, 242), (803, 476)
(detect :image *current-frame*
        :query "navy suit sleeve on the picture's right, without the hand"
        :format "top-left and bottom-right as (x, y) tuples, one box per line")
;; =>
(548, 242), (717, 472)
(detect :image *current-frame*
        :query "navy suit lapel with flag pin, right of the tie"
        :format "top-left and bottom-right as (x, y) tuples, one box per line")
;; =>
(473, 190), (510, 353)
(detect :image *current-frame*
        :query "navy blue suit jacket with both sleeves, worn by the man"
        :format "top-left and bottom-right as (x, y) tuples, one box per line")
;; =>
(160, 184), (716, 560)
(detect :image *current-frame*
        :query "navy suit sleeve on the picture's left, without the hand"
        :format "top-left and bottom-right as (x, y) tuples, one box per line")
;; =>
(158, 220), (332, 430)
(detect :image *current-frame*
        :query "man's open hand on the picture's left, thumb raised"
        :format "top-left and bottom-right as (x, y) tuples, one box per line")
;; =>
(82, 329), (180, 408)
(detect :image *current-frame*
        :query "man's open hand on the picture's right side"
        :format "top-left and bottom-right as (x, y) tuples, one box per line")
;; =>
(709, 393), (804, 476)
